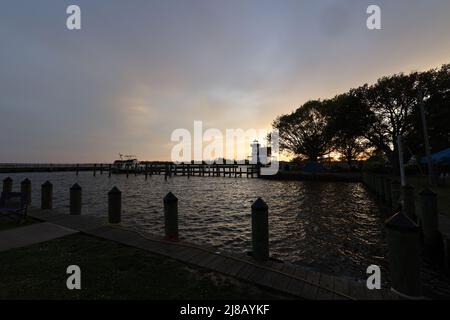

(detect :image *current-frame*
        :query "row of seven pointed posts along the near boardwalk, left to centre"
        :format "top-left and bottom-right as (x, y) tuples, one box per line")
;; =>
(3, 177), (270, 261)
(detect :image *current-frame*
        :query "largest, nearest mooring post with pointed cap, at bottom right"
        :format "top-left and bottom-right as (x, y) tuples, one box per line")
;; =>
(385, 212), (422, 299)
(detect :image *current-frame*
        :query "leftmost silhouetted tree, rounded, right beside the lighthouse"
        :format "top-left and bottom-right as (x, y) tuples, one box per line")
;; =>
(273, 101), (331, 161)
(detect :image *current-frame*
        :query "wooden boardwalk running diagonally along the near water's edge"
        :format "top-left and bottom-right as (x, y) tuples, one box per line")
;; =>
(25, 209), (398, 300)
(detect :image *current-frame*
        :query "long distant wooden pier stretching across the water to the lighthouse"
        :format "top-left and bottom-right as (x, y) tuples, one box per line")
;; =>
(0, 161), (261, 178)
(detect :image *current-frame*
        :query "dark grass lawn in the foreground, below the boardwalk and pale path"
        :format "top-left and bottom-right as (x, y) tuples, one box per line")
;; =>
(0, 234), (292, 299)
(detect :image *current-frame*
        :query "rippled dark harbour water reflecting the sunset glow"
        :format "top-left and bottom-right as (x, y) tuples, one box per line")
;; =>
(0, 172), (387, 279)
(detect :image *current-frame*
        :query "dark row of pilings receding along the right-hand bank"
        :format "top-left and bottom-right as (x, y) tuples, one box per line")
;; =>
(362, 172), (449, 299)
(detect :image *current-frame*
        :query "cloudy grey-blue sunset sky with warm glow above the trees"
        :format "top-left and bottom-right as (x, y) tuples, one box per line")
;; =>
(0, 0), (450, 163)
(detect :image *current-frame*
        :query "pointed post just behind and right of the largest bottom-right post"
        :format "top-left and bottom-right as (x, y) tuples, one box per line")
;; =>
(419, 188), (441, 246)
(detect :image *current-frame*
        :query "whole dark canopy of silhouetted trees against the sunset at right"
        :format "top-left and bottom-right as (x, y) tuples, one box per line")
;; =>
(273, 64), (450, 174)
